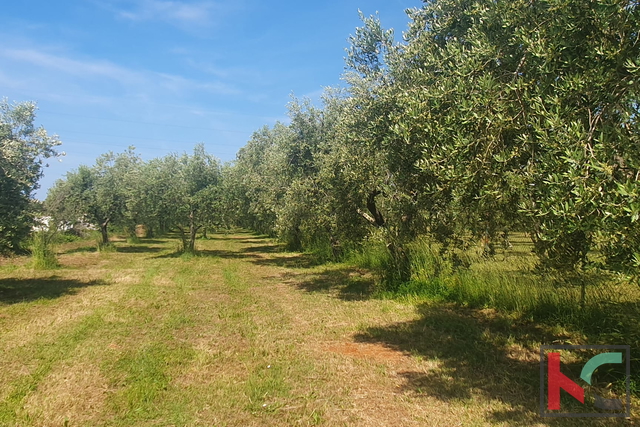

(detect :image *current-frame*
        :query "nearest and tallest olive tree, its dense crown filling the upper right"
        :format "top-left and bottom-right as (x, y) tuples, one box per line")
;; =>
(361, 0), (640, 269)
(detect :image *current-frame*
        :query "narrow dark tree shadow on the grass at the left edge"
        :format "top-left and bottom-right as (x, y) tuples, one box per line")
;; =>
(0, 276), (107, 304)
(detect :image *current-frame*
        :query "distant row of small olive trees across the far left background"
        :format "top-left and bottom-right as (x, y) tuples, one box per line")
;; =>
(45, 145), (223, 252)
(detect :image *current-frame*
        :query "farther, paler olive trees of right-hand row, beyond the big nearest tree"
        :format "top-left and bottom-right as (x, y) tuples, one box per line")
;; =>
(225, 91), (382, 257)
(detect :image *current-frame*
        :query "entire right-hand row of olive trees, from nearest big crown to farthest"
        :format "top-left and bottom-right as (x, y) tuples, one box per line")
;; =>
(221, 0), (640, 277)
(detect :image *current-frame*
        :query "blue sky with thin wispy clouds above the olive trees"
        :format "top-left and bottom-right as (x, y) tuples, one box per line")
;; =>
(0, 0), (421, 198)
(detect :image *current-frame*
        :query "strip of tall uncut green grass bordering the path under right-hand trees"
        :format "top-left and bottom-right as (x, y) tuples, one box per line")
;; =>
(350, 239), (624, 324)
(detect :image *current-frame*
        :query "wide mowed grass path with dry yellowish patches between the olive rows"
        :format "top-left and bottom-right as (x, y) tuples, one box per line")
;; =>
(0, 233), (635, 426)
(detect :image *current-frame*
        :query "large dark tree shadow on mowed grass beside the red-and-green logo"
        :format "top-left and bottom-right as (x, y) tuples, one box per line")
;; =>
(355, 304), (622, 426)
